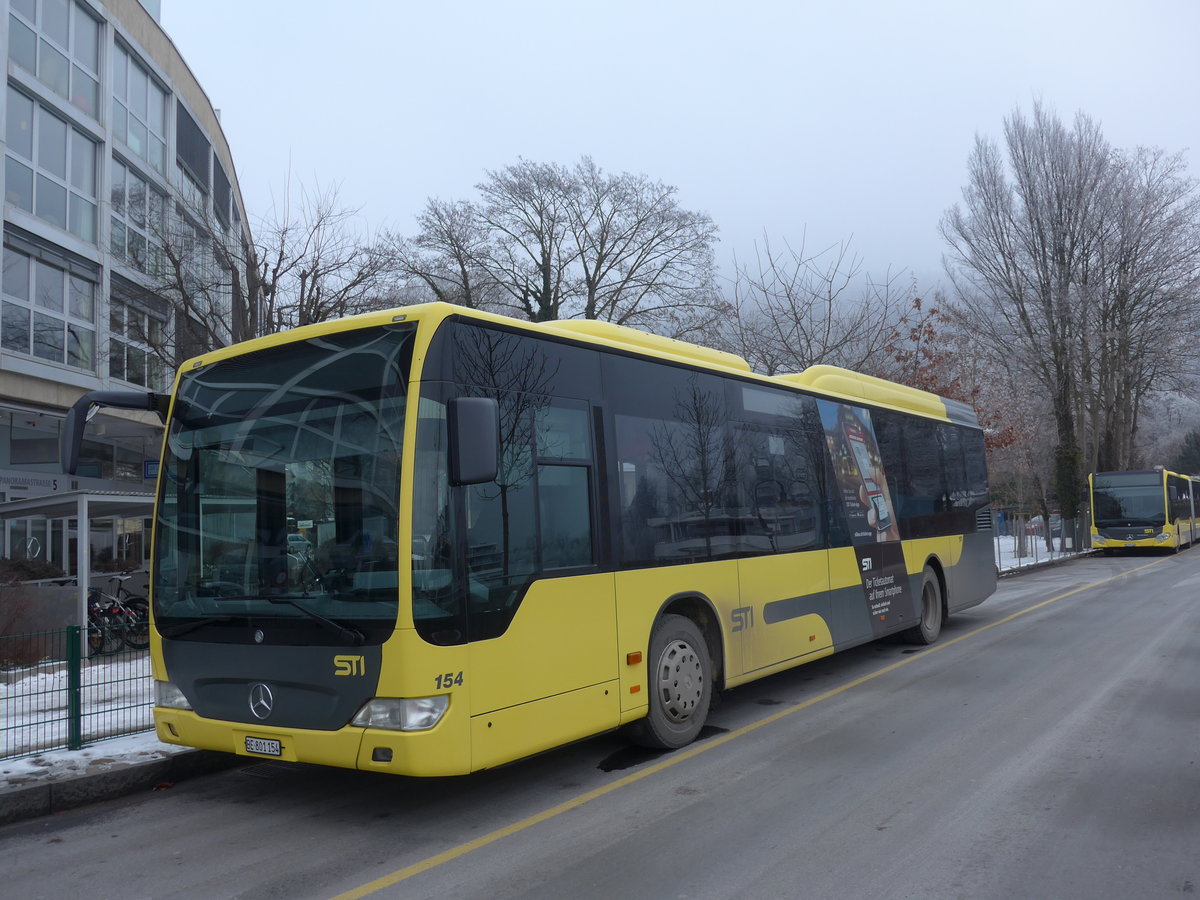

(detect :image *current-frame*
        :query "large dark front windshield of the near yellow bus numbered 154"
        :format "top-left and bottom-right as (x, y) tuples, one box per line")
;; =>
(154, 324), (415, 646)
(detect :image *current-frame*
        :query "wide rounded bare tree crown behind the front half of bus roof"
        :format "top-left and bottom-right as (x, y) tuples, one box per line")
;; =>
(391, 157), (725, 337)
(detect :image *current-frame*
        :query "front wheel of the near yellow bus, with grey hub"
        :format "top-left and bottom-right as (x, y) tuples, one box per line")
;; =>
(629, 616), (713, 750)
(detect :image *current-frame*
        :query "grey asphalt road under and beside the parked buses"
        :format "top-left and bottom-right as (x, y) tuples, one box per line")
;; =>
(0, 550), (1200, 900)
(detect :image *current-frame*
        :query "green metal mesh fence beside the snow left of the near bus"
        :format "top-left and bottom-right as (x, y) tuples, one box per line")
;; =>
(0, 625), (154, 760)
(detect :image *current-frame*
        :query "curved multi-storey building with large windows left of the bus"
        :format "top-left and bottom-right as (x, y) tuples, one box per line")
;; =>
(0, 0), (250, 571)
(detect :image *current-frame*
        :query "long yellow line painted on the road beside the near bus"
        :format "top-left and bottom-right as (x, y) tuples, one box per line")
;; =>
(331, 557), (1174, 900)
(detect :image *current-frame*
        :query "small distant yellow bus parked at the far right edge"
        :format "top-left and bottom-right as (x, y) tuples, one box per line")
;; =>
(1087, 467), (1200, 553)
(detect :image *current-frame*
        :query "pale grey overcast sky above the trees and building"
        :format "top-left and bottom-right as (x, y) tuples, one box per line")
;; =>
(162, 0), (1200, 290)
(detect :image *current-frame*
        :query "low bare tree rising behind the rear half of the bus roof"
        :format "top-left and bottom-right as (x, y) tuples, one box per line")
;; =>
(728, 235), (908, 374)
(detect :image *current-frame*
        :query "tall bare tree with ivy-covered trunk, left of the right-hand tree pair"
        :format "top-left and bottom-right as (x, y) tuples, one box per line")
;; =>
(942, 106), (1110, 518)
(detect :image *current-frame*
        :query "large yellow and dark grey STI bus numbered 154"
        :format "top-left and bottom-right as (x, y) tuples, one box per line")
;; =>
(62, 304), (996, 775)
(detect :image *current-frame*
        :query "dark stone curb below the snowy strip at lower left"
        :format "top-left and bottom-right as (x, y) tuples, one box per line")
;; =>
(0, 750), (246, 826)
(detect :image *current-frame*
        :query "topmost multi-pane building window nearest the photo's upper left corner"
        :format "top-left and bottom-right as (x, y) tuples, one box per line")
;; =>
(8, 0), (100, 119)
